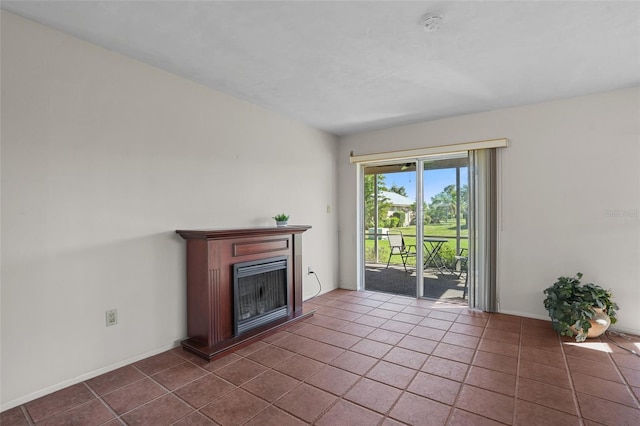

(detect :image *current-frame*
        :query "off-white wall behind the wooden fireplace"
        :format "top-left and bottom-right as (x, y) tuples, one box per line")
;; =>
(0, 12), (338, 410)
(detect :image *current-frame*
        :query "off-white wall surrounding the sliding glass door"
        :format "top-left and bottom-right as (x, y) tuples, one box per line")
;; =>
(338, 88), (640, 333)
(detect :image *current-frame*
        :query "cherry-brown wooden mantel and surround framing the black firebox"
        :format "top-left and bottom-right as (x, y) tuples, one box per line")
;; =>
(176, 225), (313, 360)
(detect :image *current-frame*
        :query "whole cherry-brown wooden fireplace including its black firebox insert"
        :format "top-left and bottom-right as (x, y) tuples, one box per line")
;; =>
(176, 225), (313, 360)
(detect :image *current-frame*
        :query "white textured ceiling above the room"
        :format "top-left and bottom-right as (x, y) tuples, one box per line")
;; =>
(2, 1), (640, 135)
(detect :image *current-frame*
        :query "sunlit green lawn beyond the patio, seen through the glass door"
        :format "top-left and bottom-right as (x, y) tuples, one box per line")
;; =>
(365, 220), (469, 267)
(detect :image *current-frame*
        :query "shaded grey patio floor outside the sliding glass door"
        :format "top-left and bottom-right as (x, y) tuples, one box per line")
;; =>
(365, 263), (466, 303)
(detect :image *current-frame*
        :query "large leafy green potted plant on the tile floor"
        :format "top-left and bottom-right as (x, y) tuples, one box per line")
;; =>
(544, 272), (620, 342)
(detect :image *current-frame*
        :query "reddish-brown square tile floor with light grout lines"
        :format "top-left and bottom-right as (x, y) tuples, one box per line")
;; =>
(0, 290), (640, 426)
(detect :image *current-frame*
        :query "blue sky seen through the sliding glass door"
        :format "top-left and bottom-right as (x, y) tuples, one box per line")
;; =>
(385, 167), (467, 203)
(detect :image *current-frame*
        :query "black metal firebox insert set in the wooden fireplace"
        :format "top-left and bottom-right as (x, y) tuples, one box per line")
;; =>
(233, 256), (289, 336)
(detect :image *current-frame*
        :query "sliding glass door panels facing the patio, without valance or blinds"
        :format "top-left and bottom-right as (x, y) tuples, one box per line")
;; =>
(363, 153), (469, 301)
